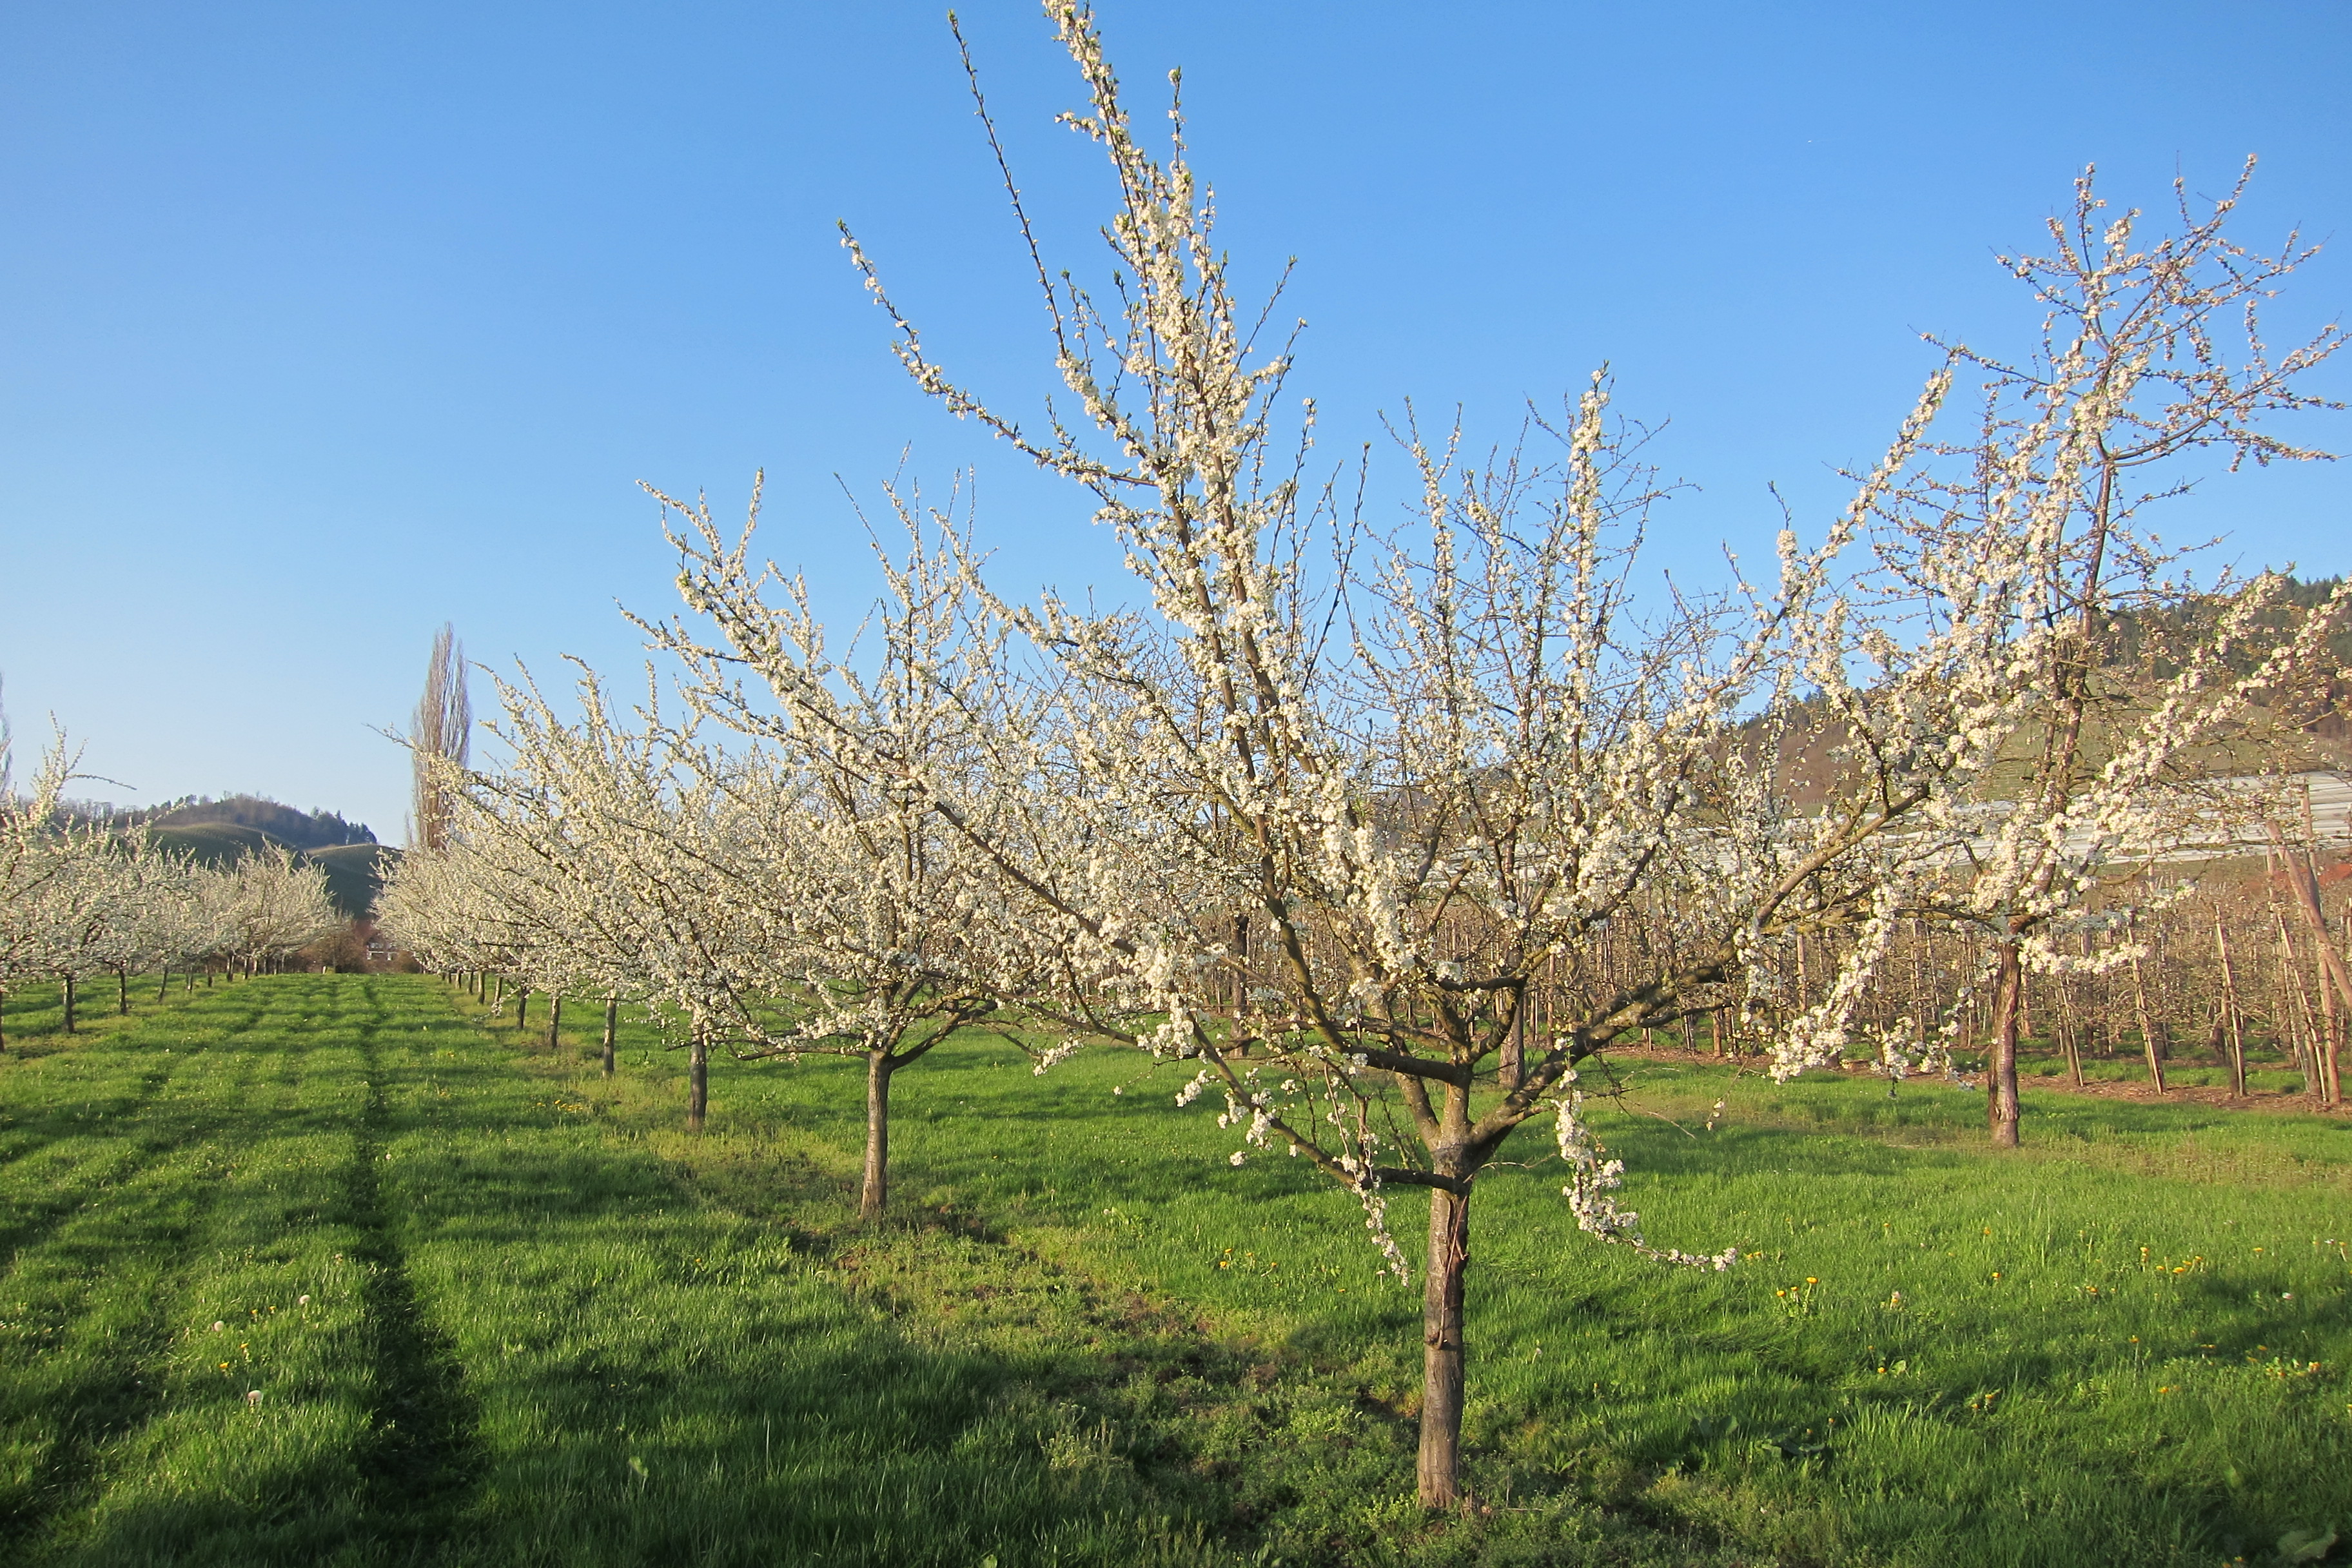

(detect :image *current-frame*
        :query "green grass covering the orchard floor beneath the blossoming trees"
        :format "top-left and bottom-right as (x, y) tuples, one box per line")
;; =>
(0, 975), (2352, 1568)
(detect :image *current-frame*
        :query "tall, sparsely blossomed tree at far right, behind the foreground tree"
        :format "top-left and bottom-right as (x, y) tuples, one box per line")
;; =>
(1877, 160), (2347, 1147)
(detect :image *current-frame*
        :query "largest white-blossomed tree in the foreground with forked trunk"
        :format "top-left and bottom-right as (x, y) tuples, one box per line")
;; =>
(672, 0), (2117, 1505)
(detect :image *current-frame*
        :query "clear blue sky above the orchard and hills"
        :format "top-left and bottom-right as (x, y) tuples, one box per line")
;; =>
(0, 0), (2352, 839)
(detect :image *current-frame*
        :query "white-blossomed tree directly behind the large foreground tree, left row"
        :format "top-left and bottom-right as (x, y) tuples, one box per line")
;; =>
(645, 496), (1119, 1220)
